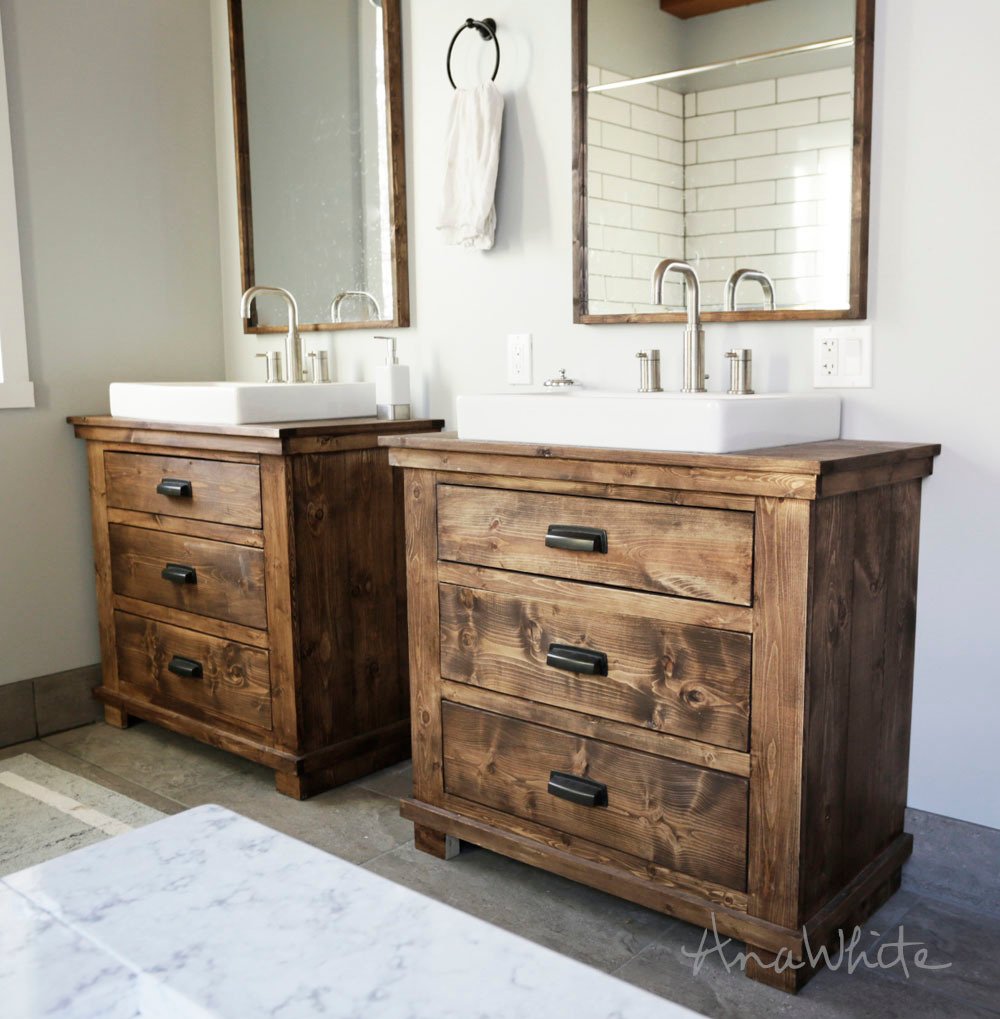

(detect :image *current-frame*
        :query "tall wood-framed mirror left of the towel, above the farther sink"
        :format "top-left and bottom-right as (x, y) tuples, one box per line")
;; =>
(229, 0), (408, 331)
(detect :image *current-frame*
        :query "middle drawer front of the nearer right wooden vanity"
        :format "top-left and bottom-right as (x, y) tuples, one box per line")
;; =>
(439, 584), (750, 750)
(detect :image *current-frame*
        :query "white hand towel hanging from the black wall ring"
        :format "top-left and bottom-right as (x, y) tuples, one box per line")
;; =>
(437, 82), (504, 250)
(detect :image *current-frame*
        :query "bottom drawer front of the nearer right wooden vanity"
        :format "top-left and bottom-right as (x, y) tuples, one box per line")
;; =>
(441, 701), (748, 891)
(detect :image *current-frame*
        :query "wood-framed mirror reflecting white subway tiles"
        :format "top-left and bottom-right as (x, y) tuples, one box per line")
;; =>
(575, 0), (871, 321)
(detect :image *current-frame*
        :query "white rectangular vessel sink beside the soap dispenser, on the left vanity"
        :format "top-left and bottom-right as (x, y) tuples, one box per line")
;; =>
(111, 382), (375, 425)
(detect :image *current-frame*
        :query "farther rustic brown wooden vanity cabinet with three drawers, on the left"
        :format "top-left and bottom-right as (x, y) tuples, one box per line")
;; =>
(69, 417), (441, 799)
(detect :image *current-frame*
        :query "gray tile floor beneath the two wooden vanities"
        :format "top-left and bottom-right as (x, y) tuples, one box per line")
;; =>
(0, 723), (1000, 1019)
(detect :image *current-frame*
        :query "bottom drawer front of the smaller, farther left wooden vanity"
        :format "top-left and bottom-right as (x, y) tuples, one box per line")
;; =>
(114, 612), (271, 730)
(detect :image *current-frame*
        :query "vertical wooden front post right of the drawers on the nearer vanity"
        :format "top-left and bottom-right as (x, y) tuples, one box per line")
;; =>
(747, 498), (812, 927)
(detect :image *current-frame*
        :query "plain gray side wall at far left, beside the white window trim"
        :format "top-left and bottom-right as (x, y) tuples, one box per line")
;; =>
(0, 0), (222, 683)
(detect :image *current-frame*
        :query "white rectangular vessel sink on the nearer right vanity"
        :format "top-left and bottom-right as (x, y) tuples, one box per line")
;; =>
(458, 389), (840, 452)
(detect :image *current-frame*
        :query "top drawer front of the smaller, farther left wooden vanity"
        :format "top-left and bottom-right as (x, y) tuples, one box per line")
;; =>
(104, 452), (261, 527)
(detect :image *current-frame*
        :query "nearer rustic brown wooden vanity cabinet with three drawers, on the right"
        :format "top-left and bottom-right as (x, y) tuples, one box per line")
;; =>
(382, 435), (940, 990)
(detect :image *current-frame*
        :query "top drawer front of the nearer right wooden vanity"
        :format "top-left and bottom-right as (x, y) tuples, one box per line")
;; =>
(437, 485), (753, 605)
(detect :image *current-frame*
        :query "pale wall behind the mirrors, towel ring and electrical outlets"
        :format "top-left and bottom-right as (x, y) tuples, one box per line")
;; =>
(232, 0), (1000, 826)
